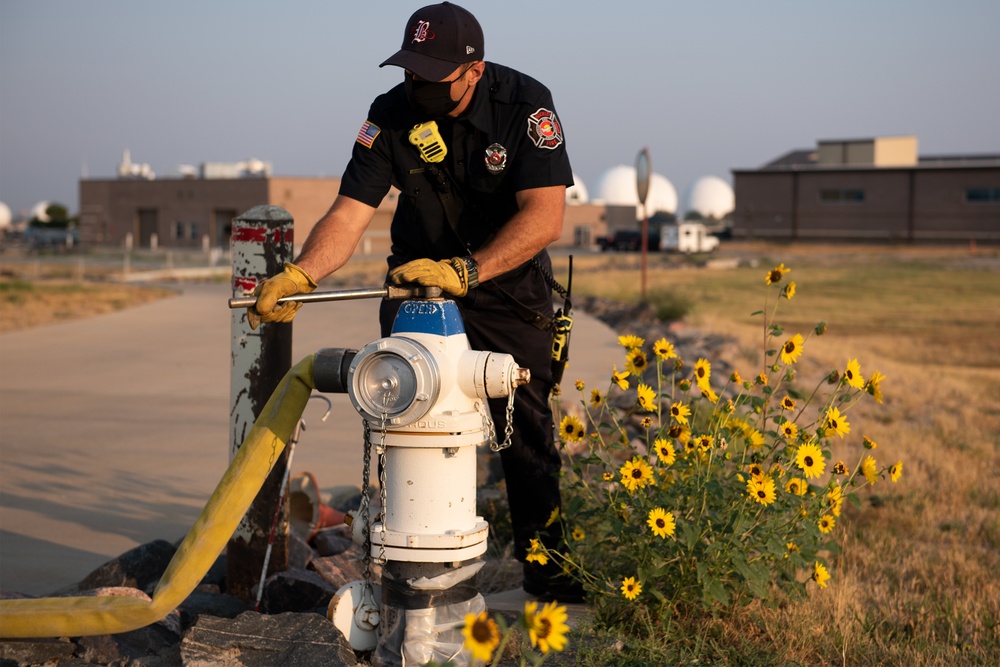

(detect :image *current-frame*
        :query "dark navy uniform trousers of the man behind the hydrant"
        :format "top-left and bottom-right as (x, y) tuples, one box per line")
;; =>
(379, 281), (561, 561)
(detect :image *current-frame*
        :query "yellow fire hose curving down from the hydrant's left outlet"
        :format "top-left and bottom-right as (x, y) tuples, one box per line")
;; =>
(0, 355), (315, 639)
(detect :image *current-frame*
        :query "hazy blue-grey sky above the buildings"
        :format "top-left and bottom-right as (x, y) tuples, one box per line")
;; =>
(0, 0), (1000, 216)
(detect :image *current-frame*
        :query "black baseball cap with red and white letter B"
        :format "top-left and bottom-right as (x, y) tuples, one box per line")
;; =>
(379, 2), (483, 81)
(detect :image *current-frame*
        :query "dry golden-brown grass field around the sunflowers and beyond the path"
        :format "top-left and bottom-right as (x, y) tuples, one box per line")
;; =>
(0, 243), (1000, 667)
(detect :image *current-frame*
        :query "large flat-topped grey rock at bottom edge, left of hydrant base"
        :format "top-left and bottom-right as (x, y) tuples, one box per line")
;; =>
(180, 611), (359, 667)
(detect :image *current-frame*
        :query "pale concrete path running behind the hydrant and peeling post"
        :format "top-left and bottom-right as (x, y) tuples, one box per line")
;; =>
(0, 284), (623, 595)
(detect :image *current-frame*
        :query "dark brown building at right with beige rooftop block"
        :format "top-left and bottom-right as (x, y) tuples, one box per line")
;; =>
(733, 136), (1000, 242)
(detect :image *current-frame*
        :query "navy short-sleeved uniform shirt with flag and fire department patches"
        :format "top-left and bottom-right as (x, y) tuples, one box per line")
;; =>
(340, 63), (573, 286)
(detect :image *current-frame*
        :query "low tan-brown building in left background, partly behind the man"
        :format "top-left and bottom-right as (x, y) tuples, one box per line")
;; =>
(80, 176), (607, 255)
